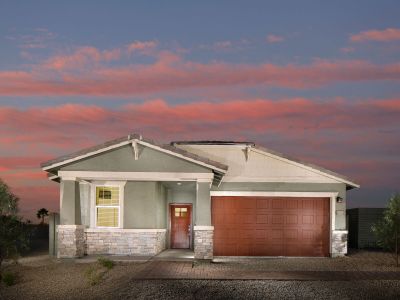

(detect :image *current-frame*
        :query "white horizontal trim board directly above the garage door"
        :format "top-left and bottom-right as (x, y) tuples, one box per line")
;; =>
(210, 191), (339, 198)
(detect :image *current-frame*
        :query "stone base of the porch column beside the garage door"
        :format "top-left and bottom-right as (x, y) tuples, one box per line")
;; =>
(193, 226), (214, 259)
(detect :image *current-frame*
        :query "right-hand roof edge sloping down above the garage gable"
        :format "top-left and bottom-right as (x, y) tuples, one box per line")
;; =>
(171, 141), (360, 188)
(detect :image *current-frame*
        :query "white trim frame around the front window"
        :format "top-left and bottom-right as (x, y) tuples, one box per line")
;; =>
(90, 181), (126, 229)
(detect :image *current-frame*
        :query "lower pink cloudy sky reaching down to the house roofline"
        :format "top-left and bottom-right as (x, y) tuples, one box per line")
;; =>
(0, 97), (400, 216)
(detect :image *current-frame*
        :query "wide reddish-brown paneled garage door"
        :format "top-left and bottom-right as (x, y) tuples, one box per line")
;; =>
(212, 196), (329, 256)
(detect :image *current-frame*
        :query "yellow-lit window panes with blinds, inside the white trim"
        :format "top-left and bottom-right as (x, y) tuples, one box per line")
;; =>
(96, 186), (121, 227)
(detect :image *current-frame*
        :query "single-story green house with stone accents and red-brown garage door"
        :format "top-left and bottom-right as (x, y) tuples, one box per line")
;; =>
(42, 134), (359, 259)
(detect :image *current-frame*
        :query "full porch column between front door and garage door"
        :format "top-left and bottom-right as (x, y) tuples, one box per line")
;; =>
(193, 182), (214, 259)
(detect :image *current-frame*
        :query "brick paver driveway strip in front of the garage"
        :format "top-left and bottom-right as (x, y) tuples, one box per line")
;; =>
(133, 260), (400, 281)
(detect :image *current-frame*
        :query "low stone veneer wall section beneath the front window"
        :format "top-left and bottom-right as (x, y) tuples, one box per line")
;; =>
(85, 228), (166, 256)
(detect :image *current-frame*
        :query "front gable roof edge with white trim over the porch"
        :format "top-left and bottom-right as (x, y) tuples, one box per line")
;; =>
(41, 134), (228, 173)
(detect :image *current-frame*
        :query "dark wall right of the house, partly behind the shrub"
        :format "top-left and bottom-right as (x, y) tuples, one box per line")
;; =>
(346, 207), (385, 249)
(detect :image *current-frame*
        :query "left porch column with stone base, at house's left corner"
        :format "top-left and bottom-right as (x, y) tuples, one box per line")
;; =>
(57, 179), (85, 258)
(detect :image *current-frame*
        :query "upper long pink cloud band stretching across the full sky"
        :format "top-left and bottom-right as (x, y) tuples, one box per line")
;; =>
(0, 55), (400, 96)
